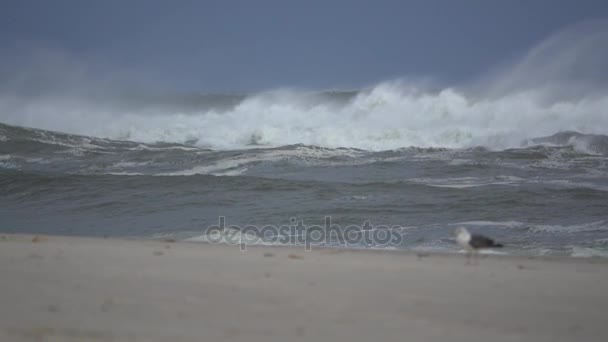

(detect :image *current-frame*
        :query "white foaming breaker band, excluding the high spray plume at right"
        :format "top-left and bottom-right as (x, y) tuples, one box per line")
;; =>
(0, 83), (608, 151)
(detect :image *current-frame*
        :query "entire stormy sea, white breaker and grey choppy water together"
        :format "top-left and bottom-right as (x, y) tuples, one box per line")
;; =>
(0, 82), (608, 256)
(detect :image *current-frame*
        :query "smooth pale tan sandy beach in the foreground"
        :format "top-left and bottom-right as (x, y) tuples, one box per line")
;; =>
(0, 235), (608, 342)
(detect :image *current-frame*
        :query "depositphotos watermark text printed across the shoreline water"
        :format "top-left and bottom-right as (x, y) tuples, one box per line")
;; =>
(205, 216), (403, 251)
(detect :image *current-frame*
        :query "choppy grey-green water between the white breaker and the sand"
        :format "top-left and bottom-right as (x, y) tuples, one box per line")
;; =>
(0, 117), (608, 256)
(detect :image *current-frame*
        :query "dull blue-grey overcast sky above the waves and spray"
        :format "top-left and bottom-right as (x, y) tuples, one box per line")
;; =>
(0, 0), (608, 92)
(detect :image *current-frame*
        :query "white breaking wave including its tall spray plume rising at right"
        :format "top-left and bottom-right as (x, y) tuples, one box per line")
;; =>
(0, 22), (608, 151)
